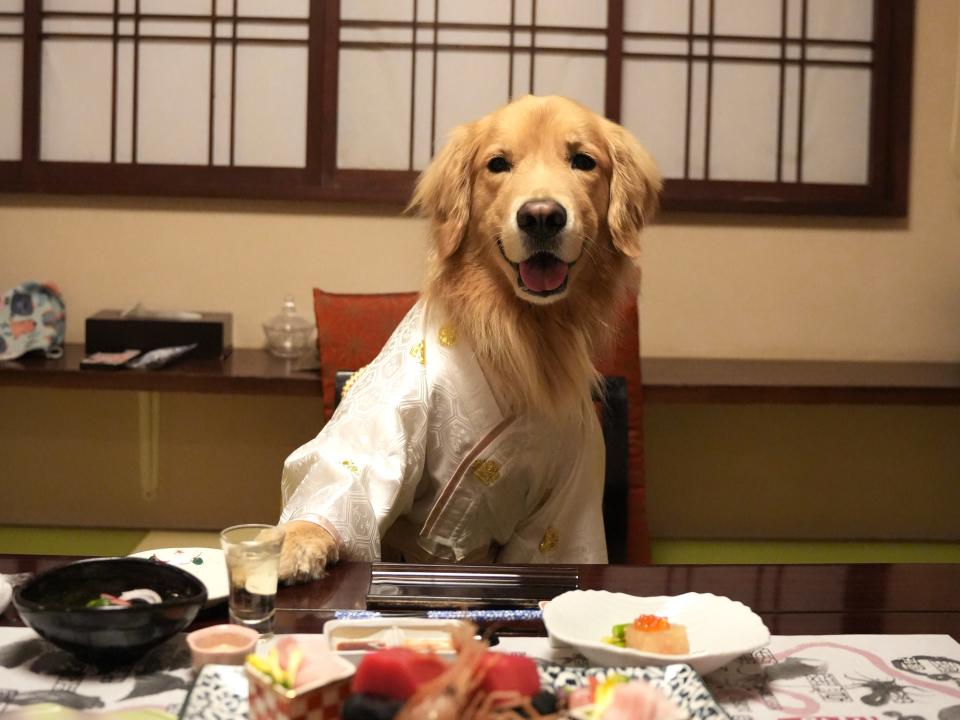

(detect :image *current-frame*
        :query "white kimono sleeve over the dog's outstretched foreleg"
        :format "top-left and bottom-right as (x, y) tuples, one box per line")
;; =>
(280, 304), (428, 561)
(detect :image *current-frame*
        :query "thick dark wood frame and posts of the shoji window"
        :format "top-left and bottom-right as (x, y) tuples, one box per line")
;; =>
(0, 0), (915, 216)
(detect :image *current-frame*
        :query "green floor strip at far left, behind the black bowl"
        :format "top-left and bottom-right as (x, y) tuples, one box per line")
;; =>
(0, 526), (147, 555)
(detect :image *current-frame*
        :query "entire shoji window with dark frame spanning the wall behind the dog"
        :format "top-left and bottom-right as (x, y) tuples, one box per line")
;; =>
(0, 0), (914, 215)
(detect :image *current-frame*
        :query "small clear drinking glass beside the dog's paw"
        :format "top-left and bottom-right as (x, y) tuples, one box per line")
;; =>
(220, 524), (284, 634)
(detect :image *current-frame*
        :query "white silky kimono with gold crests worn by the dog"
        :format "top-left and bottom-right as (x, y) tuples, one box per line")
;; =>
(281, 301), (607, 563)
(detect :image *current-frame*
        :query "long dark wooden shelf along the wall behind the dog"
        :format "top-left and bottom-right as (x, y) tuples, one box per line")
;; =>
(0, 343), (960, 405)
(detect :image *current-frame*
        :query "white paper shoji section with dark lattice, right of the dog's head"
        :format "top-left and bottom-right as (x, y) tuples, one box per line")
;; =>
(621, 0), (876, 185)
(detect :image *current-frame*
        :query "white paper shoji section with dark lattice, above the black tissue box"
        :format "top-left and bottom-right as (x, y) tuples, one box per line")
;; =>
(40, 0), (309, 167)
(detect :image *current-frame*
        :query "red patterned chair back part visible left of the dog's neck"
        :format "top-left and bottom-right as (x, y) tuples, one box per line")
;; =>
(313, 288), (417, 420)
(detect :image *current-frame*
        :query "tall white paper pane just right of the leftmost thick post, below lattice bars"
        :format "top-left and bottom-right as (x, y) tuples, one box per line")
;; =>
(40, 40), (113, 161)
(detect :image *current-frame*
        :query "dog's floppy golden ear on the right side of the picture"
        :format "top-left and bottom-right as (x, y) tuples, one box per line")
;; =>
(605, 121), (663, 257)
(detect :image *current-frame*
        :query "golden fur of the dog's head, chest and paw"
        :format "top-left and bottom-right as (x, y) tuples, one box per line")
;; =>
(280, 96), (661, 582)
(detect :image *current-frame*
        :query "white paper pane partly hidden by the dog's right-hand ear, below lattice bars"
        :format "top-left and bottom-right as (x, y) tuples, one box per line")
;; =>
(621, 60), (687, 178)
